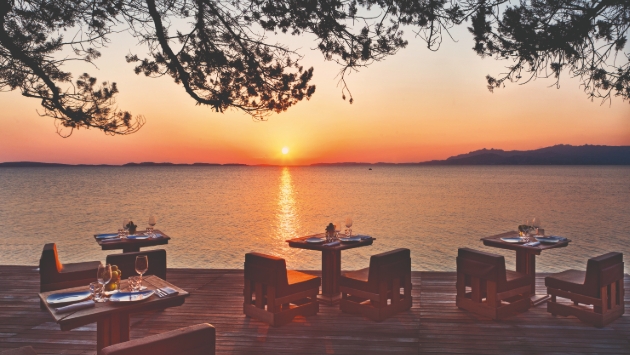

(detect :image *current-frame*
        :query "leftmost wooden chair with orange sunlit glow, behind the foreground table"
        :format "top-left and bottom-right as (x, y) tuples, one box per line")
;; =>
(39, 243), (101, 308)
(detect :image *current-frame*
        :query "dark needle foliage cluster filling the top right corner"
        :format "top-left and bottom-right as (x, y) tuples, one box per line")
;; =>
(469, 0), (630, 100)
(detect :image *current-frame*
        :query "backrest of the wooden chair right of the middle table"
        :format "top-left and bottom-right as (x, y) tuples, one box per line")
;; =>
(368, 248), (411, 287)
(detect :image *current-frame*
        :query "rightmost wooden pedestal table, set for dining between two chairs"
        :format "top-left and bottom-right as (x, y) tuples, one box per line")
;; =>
(481, 231), (571, 306)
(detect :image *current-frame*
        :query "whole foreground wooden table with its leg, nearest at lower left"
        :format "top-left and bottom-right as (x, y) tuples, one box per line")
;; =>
(39, 275), (189, 354)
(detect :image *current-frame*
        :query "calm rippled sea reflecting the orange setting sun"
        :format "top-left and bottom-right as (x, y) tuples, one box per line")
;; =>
(0, 167), (630, 272)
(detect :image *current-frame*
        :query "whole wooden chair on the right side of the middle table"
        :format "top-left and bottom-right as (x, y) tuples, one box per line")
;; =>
(339, 249), (412, 322)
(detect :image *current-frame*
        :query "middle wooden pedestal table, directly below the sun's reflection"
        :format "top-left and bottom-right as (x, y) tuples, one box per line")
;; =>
(287, 233), (376, 305)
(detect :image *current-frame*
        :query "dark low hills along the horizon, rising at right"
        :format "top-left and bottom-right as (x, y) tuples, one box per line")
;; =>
(0, 144), (630, 168)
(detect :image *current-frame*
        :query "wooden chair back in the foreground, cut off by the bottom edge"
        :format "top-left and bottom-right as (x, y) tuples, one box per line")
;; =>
(100, 323), (216, 355)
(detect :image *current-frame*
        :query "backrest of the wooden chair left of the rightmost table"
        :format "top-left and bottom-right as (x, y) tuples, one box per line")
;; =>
(457, 248), (507, 284)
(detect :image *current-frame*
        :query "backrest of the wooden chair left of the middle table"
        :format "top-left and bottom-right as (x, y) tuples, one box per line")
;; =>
(245, 252), (289, 287)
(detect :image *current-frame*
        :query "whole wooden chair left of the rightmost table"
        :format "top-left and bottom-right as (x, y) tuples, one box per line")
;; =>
(456, 248), (532, 320)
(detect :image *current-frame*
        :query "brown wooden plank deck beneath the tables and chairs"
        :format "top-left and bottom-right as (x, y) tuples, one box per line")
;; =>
(0, 266), (630, 355)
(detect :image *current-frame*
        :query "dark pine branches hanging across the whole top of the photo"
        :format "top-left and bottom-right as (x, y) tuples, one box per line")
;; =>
(0, 0), (630, 134)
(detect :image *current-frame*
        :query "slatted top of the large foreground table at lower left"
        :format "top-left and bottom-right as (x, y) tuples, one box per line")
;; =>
(39, 275), (189, 330)
